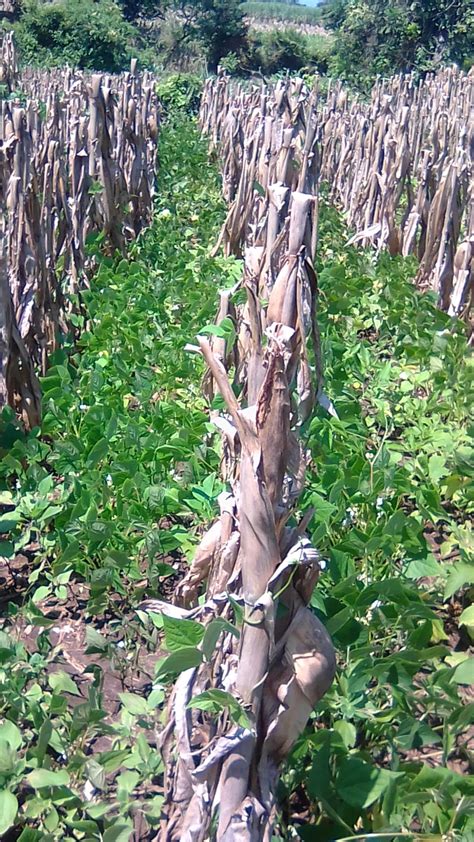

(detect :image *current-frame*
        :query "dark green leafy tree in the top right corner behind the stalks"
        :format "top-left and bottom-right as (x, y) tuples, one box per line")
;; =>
(325, 0), (474, 87)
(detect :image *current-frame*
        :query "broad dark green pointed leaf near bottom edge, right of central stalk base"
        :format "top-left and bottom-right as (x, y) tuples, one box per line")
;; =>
(336, 757), (403, 809)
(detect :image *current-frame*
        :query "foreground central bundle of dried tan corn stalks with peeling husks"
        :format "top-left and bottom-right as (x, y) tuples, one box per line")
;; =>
(146, 80), (335, 842)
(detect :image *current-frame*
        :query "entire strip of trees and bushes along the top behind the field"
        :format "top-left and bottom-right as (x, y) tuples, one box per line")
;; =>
(1, 0), (474, 81)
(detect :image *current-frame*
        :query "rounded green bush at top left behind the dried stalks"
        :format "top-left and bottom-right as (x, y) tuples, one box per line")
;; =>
(14, 0), (135, 72)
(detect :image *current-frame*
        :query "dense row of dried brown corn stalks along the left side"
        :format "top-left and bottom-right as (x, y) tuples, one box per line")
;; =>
(0, 39), (159, 425)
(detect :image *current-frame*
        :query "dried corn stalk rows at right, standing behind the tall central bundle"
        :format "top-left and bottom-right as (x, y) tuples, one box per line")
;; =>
(201, 67), (474, 315)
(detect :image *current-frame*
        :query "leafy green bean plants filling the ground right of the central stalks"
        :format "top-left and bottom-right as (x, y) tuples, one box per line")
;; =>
(283, 202), (474, 840)
